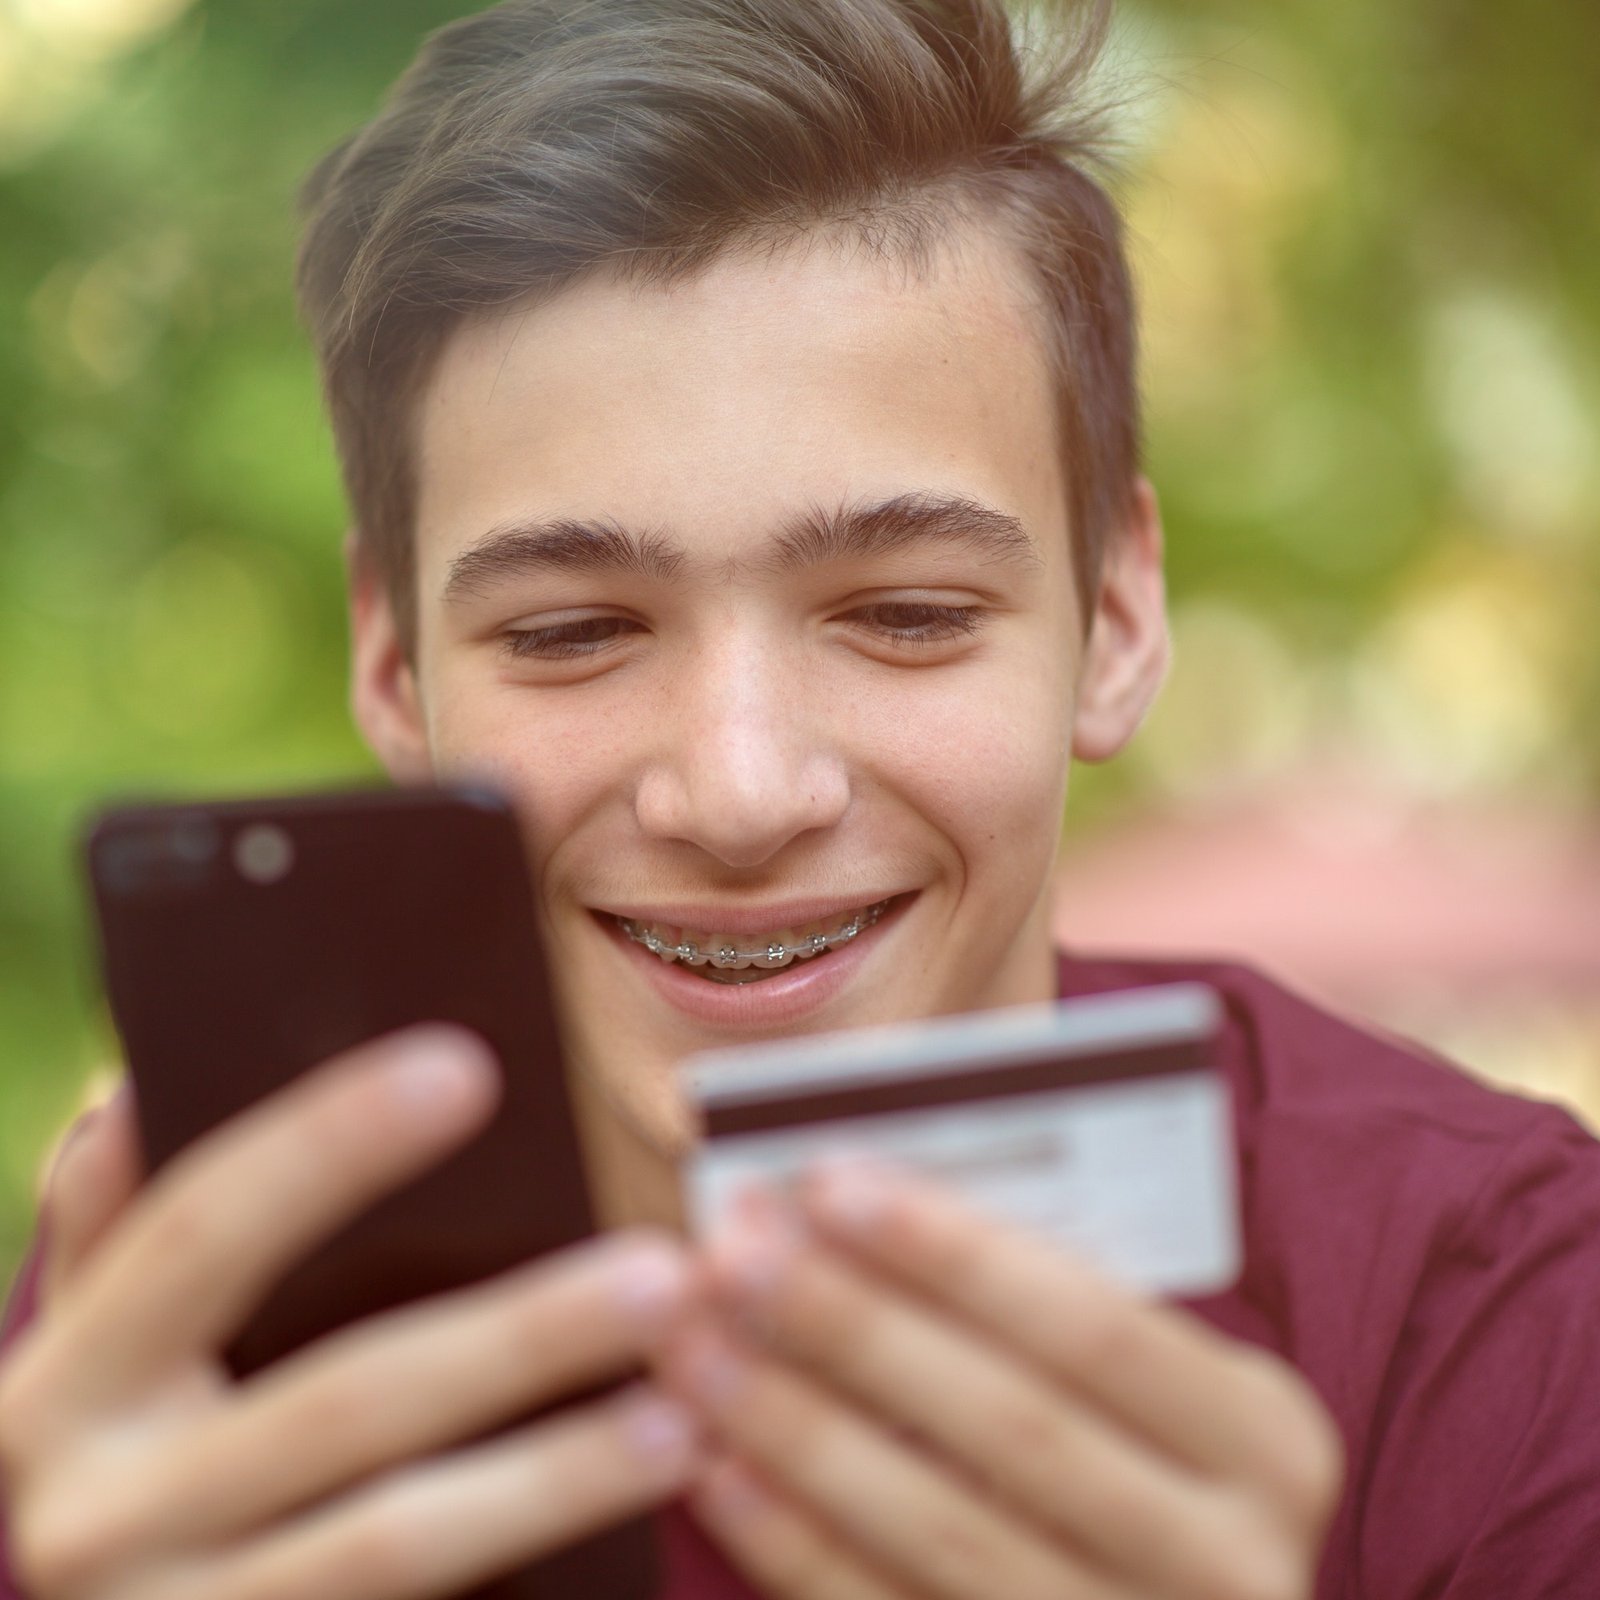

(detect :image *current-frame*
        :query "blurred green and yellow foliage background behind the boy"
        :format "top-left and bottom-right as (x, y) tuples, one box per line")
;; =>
(0, 0), (1600, 1278)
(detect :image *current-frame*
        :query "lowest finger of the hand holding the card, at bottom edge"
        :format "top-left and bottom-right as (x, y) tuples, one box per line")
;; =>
(690, 1456), (909, 1600)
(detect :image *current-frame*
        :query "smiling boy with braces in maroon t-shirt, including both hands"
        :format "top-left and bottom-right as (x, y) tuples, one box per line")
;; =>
(0, 0), (1600, 1600)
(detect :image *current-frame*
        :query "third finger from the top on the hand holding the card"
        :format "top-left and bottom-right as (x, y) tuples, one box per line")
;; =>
(666, 1326), (1123, 1600)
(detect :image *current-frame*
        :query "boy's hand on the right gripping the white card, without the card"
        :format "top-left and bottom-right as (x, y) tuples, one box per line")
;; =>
(667, 1163), (1339, 1600)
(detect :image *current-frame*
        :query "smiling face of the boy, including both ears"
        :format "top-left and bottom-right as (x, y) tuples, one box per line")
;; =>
(355, 222), (1165, 1152)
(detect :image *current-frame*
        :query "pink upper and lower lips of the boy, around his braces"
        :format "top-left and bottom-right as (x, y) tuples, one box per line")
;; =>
(594, 893), (917, 1034)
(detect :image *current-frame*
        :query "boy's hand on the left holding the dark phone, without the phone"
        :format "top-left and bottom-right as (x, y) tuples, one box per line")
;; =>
(0, 1030), (694, 1600)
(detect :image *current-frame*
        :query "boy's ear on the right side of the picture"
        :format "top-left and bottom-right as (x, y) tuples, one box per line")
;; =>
(1072, 478), (1171, 762)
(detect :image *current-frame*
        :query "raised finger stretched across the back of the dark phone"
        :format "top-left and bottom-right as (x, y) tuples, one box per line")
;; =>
(34, 1027), (498, 1427)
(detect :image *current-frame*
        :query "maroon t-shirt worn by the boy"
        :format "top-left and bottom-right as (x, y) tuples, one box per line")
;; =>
(0, 958), (1600, 1600)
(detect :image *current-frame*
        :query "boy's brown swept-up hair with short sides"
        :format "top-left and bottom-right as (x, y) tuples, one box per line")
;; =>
(298, 0), (1139, 650)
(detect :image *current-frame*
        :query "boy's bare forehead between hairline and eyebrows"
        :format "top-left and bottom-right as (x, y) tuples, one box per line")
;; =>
(416, 219), (1066, 576)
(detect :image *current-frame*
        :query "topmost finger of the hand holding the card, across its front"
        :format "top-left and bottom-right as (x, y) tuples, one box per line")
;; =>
(803, 1160), (1339, 1522)
